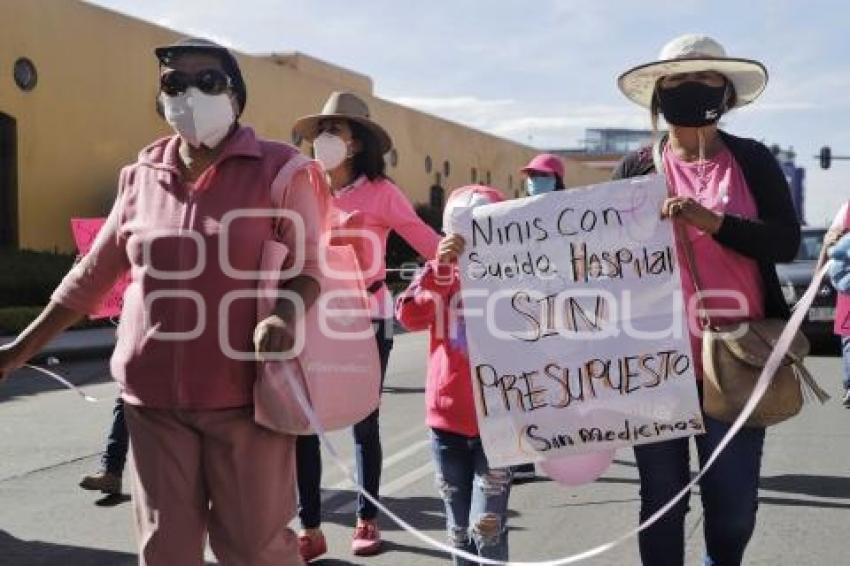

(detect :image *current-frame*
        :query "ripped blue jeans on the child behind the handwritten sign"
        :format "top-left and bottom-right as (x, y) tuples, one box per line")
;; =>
(431, 429), (511, 566)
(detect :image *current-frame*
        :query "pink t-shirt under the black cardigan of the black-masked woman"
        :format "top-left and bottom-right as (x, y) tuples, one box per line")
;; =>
(663, 145), (764, 379)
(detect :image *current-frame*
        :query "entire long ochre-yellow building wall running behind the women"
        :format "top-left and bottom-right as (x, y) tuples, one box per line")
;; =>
(0, 0), (592, 250)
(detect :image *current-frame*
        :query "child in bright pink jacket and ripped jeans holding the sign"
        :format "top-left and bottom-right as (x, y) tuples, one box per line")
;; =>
(396, 185), (511, 565)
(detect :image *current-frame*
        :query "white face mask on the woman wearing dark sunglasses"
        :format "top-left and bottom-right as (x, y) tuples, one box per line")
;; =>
(162, 87), (236, 149)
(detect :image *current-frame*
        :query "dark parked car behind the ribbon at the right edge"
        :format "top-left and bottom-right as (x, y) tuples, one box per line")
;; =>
(776, 227), (838, 348)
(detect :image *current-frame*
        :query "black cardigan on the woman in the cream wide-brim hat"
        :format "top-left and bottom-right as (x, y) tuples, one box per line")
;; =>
(613, 131), (800, 319)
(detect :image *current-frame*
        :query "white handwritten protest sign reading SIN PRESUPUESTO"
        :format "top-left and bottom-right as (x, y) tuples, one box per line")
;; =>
(453, 176), (703, 466)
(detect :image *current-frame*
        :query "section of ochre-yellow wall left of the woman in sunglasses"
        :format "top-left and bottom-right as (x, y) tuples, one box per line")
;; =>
(0, 0), (179, 250)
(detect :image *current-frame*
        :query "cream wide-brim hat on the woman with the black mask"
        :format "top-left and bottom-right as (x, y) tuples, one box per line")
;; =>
(617, 34), (767, 108)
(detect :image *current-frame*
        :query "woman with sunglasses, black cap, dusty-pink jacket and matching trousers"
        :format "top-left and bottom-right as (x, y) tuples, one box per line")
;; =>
(0, 40), (327, 566)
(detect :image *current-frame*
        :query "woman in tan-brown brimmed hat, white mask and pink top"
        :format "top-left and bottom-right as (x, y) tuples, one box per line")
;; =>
(294, 92), (439, 560)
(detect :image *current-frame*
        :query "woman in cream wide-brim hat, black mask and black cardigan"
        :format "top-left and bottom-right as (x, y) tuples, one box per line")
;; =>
(614, 35), (800, 566)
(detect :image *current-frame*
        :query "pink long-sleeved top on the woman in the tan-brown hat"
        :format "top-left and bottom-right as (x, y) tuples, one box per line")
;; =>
(333, 176), (440, 319)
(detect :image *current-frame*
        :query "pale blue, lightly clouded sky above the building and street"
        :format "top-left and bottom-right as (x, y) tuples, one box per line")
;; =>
(90, 0), (850, 224)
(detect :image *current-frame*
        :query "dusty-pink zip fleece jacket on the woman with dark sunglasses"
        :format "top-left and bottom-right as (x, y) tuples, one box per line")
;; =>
(53, 127), (328, 410)
